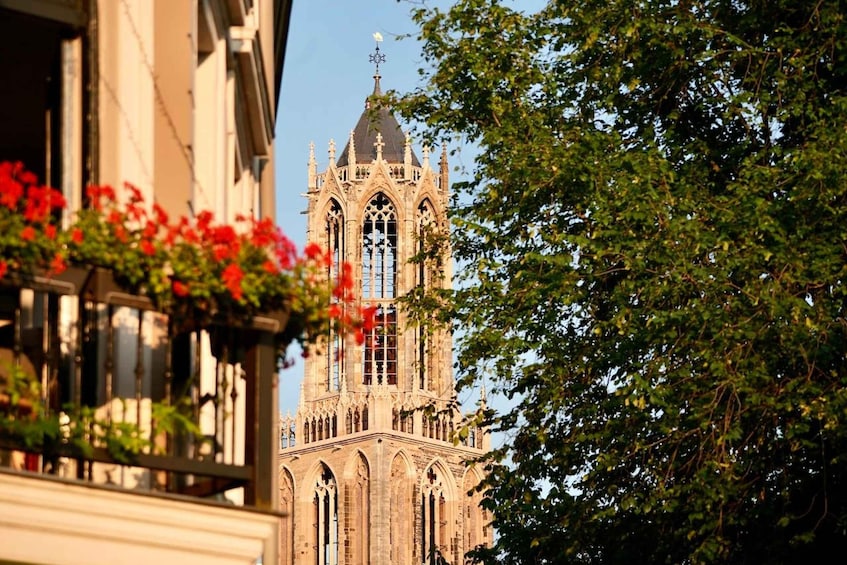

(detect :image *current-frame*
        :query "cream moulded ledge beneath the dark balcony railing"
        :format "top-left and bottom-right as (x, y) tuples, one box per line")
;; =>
(0, 472), (278, 565)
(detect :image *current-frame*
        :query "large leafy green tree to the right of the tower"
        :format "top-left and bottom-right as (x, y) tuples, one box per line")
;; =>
(396, 0), (847, 564)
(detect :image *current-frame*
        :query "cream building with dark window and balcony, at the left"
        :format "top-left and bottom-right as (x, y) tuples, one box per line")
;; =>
(0, 0), (291, 565)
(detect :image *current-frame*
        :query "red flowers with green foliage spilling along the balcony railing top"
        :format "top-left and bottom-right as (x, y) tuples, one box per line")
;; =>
(0, 163), (373, 360)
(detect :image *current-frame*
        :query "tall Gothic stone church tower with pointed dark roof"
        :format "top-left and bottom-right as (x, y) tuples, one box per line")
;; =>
(279, 47), (491, 565)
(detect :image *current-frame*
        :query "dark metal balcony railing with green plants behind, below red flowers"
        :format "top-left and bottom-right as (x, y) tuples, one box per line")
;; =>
(0, 268), (286, 511)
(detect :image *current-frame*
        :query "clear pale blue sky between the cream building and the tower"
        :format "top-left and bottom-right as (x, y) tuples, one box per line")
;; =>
(275, 0), (440, 414)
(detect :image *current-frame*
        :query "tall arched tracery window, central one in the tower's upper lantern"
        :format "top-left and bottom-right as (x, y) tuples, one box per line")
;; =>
(362, 193), (397, 385)
